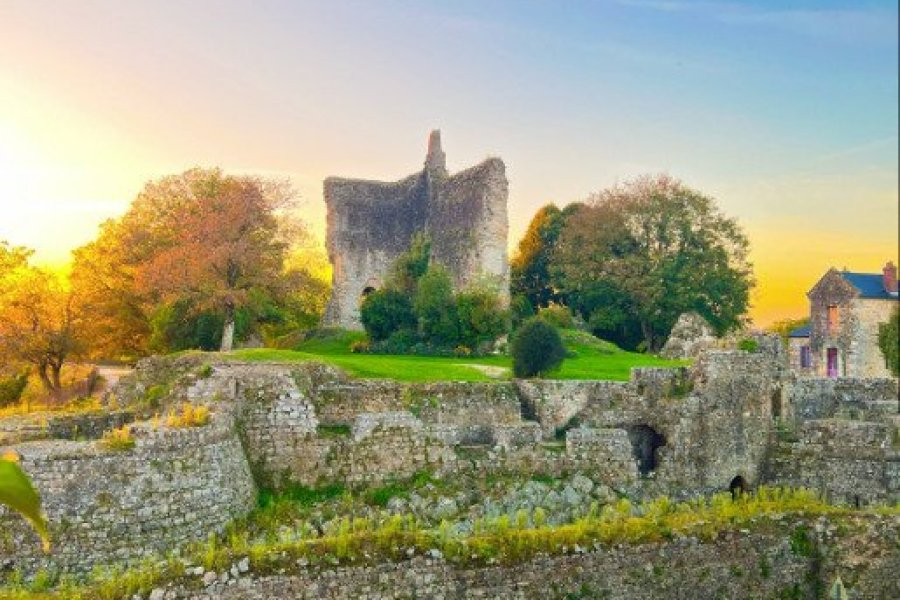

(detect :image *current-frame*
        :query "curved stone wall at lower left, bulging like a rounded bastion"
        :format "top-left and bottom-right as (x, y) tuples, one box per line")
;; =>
(0, 413), (256, 573)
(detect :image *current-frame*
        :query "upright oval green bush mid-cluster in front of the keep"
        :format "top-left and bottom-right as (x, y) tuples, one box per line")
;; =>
(413, 264), (459, 346)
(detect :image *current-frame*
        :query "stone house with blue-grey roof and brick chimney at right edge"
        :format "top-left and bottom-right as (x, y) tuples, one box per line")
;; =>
(789, 262), (898, 377)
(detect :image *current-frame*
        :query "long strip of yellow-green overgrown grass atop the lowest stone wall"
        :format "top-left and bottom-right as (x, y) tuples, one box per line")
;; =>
(0, 486), (888, 600)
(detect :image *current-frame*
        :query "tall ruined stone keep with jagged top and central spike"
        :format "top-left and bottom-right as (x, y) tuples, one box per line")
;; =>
(324, 130), (509, 329)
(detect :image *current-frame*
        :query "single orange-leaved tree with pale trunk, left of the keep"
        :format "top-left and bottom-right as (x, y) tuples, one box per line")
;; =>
(131, 169), (291, 352)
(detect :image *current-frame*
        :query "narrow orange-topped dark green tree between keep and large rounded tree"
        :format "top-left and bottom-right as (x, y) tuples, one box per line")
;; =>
(510, 204), (582, 309)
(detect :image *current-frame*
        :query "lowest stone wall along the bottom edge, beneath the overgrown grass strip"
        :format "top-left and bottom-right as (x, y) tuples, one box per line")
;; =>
(163, 533), (828, 600)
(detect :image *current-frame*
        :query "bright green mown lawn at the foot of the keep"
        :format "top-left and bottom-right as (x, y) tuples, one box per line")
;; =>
(230, 331), (687, 382)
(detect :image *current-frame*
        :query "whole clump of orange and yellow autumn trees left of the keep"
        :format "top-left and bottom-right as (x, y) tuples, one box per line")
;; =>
(72, 169), (327, 356)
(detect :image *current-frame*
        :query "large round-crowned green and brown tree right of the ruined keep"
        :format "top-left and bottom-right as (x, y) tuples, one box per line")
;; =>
(550, 175), (753, 351)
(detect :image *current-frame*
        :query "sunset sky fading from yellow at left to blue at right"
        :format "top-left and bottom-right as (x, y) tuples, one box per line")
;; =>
(0, 0), (898, 325)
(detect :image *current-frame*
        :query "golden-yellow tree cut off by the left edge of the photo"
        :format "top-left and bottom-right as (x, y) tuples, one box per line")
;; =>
(0, 243), (81, 395)
